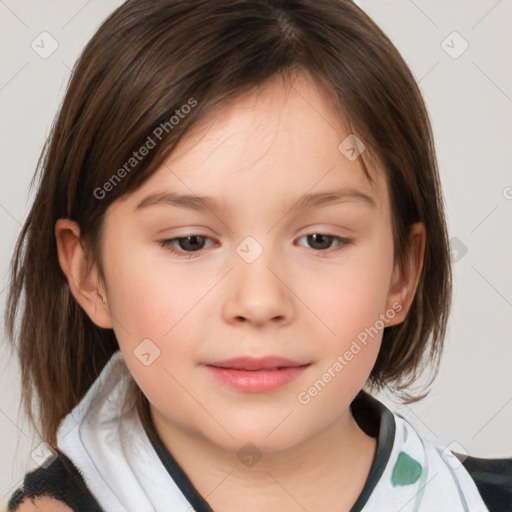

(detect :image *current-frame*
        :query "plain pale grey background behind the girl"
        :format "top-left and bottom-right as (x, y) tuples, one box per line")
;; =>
(0, 0), (512, 508)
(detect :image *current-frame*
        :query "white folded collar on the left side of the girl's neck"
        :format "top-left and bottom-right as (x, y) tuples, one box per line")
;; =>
(57, 351), (191, 512)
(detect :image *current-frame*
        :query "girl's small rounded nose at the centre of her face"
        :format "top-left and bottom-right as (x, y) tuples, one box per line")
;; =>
(222, 251), (295, 327)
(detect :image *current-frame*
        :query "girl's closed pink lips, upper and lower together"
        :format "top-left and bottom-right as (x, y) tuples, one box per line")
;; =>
(205, 356), (310, 393)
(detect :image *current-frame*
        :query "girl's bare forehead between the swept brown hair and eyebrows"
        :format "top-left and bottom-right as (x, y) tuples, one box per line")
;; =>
(125, 71), (387, 214)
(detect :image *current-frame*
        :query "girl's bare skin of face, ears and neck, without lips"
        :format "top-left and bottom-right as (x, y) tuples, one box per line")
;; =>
(56, 75), (426, 512)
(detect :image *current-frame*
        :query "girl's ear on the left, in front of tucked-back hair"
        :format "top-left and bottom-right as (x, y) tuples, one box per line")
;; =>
(55, 219), (113, 329)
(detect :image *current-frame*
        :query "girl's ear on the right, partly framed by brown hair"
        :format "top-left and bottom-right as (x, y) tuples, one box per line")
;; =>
(386, 222), (427, 327)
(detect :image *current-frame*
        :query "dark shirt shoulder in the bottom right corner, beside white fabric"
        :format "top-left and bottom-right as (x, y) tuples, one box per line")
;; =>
(456, 454), (512, 512)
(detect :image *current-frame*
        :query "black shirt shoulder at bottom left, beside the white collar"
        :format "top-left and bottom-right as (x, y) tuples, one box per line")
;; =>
(7, 449), (103, 512)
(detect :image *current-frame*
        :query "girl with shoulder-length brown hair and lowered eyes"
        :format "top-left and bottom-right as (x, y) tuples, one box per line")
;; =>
(7, 0), (511, 512)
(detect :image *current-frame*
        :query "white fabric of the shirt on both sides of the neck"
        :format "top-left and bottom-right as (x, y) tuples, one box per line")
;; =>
(57, 351), (488, 512)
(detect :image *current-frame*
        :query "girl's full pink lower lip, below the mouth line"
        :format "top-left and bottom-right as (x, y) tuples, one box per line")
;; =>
(206, 364), (309, 393)
